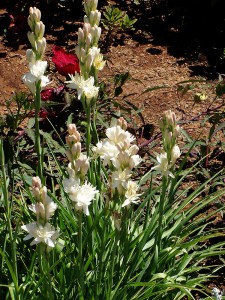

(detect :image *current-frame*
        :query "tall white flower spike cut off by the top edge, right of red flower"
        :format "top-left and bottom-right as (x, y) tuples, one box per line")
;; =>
(67, 0), (105, 106)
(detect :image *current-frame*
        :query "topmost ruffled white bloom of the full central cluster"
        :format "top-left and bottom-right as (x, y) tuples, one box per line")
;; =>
(106, 125), (135, 147)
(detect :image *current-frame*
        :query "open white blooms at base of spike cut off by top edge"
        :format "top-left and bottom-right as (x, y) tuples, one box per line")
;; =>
(66, 73), (99, 101)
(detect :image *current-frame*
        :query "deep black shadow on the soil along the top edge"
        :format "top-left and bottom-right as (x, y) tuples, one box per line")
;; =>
(0, 0), (225, 79)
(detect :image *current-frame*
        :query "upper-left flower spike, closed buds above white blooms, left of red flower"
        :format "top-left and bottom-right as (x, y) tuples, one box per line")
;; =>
(22, 7), (49, 95)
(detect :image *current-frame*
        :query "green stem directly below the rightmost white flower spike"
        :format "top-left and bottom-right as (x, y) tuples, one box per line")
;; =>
(152, 176), (167, 272)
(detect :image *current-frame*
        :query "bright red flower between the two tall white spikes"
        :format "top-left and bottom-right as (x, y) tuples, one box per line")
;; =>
(52, 46), (80, 76)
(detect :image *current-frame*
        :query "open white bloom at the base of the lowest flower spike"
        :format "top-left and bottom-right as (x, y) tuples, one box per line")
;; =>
(21, 222), (59, 247)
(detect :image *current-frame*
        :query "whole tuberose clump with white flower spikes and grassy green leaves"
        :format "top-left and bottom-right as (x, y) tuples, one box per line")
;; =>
(0, 0), (225, 300)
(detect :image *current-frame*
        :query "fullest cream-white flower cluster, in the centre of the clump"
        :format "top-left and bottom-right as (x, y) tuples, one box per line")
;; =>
(93, 118), (141, 207)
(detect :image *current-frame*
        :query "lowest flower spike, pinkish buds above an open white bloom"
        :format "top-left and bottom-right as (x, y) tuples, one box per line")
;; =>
(21, 177), (59, 248)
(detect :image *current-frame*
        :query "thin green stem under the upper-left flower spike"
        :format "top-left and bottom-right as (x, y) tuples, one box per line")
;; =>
(34, 81), (43, 183)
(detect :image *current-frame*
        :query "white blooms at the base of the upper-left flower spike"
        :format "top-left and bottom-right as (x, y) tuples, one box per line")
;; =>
(22, 60), (49, 94)
